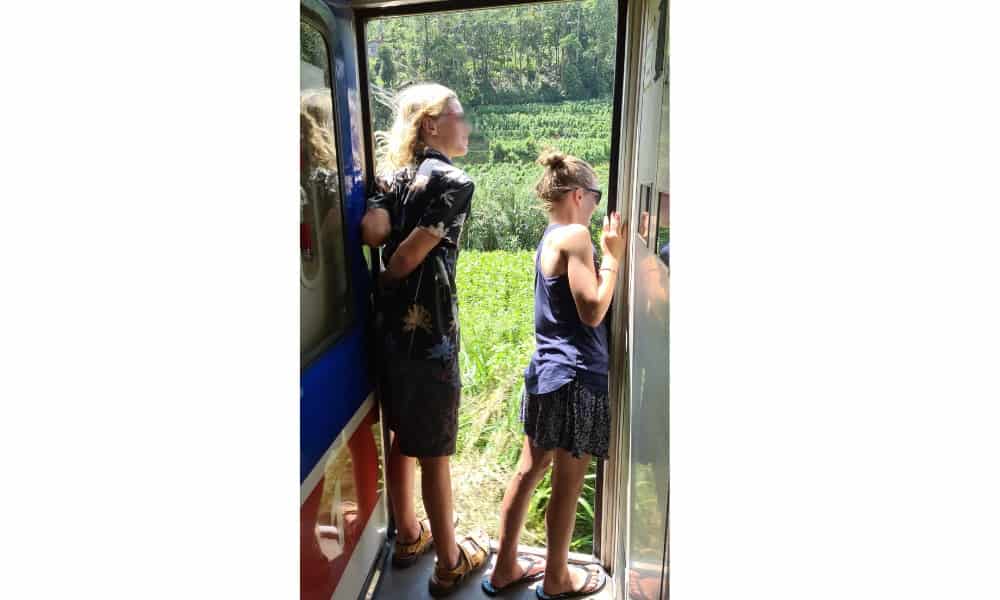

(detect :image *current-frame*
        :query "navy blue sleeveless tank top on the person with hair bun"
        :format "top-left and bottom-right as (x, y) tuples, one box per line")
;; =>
(524, 224), (608, 394)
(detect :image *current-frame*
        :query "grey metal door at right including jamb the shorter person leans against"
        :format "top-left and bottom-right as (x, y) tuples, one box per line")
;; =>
(603, 0), (670, 600)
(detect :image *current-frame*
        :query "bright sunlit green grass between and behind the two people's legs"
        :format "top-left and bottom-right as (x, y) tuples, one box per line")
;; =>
(408, 250), (596, 552)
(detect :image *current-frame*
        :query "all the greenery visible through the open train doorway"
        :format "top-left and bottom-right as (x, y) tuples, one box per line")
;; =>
(364, 0), (618, 554)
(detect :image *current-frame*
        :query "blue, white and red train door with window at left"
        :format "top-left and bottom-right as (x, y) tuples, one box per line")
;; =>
(298, 0), (387, 600)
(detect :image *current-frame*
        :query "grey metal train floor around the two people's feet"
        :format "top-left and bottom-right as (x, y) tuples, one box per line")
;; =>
(373, 550), (614, 600)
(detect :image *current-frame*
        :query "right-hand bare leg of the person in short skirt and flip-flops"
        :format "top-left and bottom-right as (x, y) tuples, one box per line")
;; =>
(542, 449), (590, 595)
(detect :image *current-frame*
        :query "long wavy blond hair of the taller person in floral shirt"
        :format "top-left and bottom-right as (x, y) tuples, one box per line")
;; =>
(375, 83), (458, 174)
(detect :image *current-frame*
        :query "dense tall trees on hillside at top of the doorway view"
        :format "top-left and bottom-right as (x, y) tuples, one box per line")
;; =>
(367, 0), (617, 117)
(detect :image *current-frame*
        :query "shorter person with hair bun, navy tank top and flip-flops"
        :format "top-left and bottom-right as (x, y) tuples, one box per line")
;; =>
(482, 149), (625, 600)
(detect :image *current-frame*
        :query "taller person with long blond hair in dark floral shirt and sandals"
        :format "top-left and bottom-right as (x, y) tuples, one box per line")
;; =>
(361, 84), (490, 596)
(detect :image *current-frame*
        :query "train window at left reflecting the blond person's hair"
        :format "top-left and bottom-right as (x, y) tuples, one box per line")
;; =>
(299, 22), (351, 362)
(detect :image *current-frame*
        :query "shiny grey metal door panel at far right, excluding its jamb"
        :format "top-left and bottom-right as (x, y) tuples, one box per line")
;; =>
(623, 0), (670, 598)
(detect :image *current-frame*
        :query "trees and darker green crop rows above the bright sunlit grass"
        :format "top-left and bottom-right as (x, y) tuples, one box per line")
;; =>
(366, 0), (617, 250)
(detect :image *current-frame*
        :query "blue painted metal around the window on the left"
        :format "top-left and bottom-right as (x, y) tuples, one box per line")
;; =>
(299, 0), (372, 483)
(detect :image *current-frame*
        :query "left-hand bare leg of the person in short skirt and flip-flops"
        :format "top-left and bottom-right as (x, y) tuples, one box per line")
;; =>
(490, 436), (552, 587)
